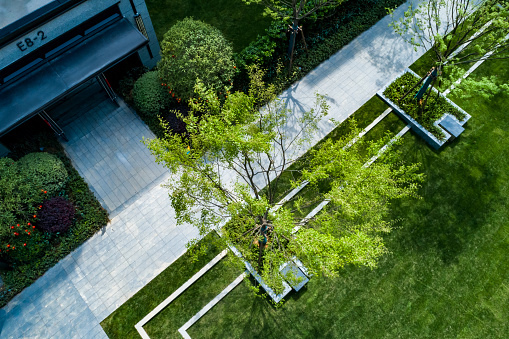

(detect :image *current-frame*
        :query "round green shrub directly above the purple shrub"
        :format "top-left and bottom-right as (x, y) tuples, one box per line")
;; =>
(17, 152), (69, 196)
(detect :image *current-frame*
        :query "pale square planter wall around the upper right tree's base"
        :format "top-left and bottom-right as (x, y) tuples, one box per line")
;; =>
(376, 68), (471, 149)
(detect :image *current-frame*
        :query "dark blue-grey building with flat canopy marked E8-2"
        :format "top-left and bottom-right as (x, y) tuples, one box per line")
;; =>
(0, 0), (159, 155)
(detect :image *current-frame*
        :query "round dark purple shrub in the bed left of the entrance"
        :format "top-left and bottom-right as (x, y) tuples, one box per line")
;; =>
(37, 197), (75, 233)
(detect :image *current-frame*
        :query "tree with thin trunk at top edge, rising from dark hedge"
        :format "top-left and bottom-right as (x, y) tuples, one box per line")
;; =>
(243, 0), (345, 72)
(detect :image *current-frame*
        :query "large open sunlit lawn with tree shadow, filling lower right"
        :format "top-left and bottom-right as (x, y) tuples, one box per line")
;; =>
(184, 57), (509, 338)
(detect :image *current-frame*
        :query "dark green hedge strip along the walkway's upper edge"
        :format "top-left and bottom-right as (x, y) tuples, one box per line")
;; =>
(234, 0), (404, 90)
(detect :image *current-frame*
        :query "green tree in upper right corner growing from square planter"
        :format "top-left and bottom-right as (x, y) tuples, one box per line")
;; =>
(391, 0), (509, 113)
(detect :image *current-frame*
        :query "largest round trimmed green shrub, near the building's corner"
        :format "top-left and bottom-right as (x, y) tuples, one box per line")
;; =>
(158, 18), (236, 102)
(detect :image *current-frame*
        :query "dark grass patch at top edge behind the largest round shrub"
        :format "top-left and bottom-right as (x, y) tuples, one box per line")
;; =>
(146, 0), (270, 52)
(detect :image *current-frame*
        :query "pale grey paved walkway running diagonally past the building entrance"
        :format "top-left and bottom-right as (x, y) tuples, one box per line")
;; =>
(0, 1), (422, 338)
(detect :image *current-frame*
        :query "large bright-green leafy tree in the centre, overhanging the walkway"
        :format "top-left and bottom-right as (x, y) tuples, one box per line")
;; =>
(146, 70), (421, 291)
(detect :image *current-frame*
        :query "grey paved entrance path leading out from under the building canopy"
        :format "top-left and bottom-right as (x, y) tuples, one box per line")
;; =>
(53, 79), (167, 216)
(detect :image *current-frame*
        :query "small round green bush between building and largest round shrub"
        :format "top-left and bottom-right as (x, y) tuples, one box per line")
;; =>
(133, 71), (171, 116)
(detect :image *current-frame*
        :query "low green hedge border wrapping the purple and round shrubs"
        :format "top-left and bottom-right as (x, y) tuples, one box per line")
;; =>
(0, 132), (108, 307)
